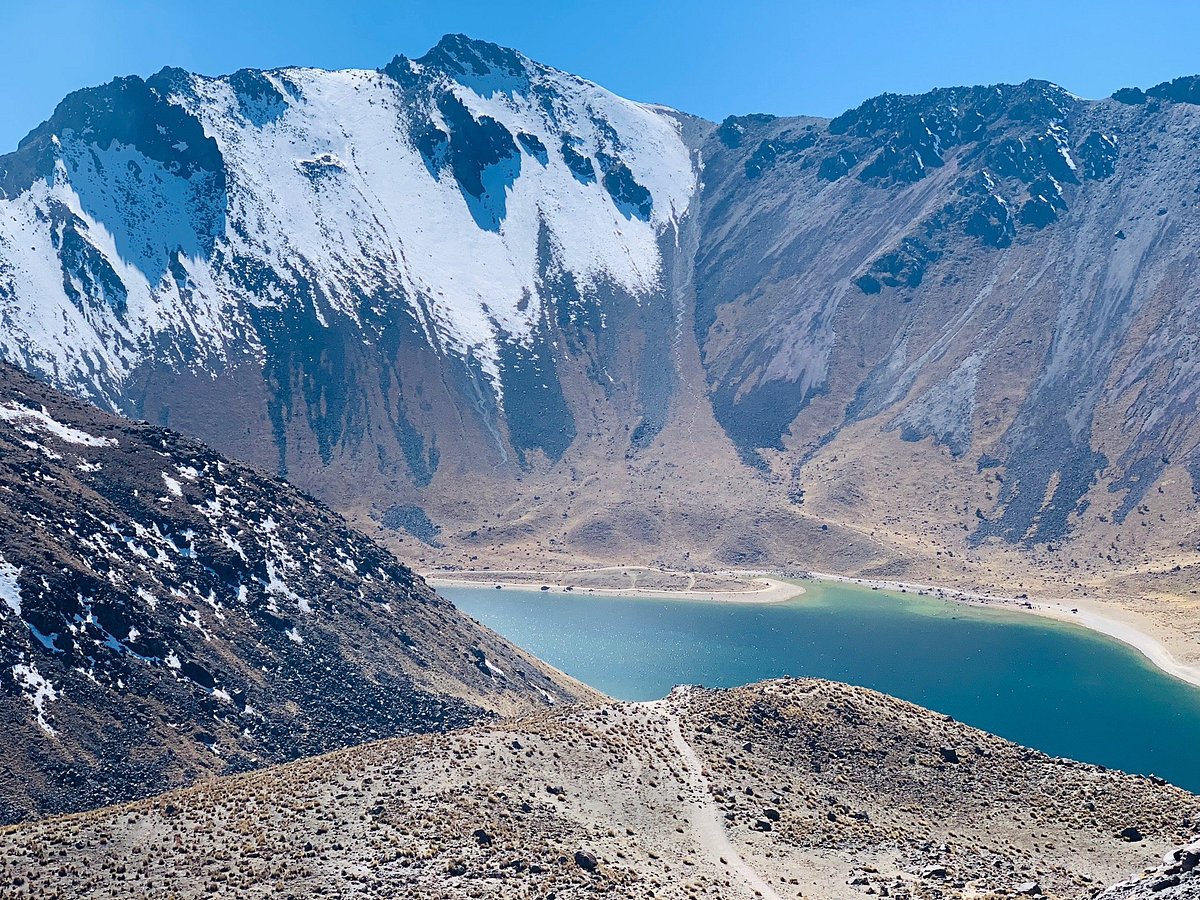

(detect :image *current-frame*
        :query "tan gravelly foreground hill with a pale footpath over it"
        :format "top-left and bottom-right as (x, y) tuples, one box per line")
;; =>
(0, 680), (1200, 900)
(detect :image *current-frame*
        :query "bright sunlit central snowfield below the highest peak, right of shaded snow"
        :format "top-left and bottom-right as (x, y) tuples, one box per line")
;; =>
(180, 64), (695, 380)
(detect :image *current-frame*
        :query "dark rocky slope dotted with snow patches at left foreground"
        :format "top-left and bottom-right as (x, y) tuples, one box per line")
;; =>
(0, 364), (593, 822)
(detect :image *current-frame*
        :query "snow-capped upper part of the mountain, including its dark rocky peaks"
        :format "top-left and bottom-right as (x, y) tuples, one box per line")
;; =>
(0, 31), (695, 462)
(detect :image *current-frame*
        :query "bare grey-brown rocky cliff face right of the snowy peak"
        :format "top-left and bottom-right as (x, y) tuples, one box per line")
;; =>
(697, 82), (1200, 544)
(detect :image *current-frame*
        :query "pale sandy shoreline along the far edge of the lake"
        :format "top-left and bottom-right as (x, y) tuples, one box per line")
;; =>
(424, 566), (1200, 688)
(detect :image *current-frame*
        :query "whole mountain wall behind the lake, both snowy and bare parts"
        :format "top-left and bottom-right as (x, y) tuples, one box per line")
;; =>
(0, 36), (1200, 590)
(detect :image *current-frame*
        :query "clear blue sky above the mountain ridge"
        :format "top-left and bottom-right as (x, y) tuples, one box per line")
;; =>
(0, 0), (1200, 152)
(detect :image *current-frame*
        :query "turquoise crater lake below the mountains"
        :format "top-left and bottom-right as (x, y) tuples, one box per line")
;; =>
(440, 583), (1200, 792)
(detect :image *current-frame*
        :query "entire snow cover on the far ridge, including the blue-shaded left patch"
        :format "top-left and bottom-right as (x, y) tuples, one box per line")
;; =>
(0, 45), (696, 403)
